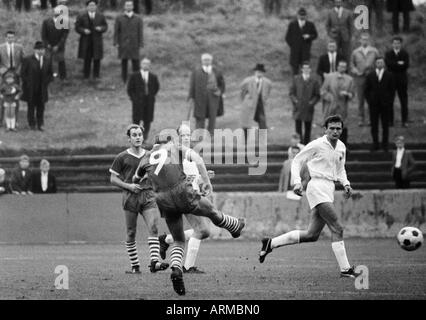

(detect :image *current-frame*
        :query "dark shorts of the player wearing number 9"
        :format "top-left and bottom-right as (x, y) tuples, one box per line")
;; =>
(156, 182), (201, 218)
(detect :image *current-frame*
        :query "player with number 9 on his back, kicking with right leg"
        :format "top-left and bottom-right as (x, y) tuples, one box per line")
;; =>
(133, 132), (245, 295)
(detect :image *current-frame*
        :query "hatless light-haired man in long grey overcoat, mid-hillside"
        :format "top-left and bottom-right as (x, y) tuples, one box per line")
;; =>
(188, 53), (225, 136)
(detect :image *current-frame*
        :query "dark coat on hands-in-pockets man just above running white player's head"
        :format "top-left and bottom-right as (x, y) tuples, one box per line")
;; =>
(290, 74), (320, 122)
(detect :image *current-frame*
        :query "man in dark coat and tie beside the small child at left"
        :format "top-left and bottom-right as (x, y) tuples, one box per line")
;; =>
(21, 41), (53, 131)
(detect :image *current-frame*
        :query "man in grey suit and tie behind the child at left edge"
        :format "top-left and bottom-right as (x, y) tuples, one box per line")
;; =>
(0, 30), (24, 126)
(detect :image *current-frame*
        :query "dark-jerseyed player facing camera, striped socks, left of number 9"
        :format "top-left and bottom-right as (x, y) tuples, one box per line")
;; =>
(109, 125), (169, 274)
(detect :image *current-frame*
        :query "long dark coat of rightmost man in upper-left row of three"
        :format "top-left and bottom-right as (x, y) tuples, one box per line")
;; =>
(114, 14), (143, 60)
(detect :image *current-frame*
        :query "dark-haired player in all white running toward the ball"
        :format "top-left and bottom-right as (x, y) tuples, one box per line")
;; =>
(259, 116), (358, 278)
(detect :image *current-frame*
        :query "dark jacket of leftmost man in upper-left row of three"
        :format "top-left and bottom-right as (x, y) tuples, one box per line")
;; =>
(41, 18), (69, 60)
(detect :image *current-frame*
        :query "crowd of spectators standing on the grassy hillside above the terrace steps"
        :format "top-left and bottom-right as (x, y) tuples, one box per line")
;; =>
(0, 0), (422, 192)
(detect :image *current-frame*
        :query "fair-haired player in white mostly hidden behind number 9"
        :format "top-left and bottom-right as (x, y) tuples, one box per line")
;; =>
(159, 124), (214, 273)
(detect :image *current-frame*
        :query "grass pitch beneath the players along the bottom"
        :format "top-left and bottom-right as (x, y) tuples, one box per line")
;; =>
(0, 239), (426, 300)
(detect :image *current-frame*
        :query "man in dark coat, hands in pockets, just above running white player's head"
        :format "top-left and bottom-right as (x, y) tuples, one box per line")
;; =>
(290, 62), (320, 145)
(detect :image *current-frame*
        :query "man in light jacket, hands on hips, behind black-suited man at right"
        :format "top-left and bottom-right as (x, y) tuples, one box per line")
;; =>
(351, 32), (379, 127)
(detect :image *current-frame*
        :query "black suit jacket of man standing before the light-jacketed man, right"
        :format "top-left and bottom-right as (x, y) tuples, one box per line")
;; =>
(365, 70), (395, 109)
